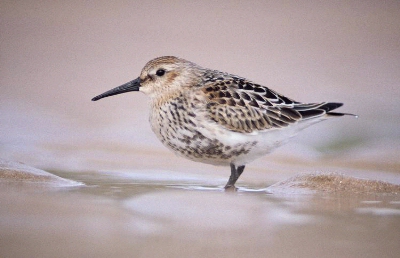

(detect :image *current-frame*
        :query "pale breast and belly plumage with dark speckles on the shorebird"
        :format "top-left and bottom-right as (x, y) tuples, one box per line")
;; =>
(150, 88), (256, 165)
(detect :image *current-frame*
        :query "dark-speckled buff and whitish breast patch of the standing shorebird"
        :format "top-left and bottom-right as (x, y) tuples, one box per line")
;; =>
(150, 93), (252, 165)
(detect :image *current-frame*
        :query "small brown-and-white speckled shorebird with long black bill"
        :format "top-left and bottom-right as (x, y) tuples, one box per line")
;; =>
(92, 56), (352, 189)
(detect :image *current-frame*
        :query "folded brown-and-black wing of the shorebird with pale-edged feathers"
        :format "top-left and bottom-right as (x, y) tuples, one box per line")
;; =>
(201, 73), (341, 133)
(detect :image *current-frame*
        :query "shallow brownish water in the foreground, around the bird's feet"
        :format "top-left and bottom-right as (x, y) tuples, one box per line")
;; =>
(0, 166), (400, 257)
